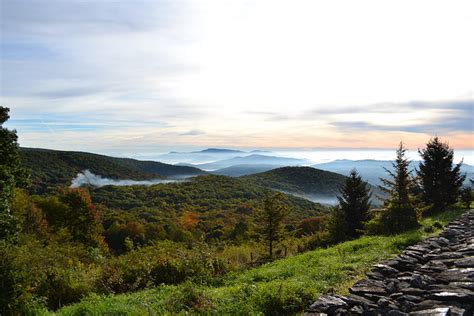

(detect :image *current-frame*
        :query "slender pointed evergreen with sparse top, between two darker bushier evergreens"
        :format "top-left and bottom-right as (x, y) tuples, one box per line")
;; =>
(380, 142), (418, 234)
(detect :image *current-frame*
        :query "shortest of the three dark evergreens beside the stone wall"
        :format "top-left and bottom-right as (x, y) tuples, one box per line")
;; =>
(337, 169), (371, 238)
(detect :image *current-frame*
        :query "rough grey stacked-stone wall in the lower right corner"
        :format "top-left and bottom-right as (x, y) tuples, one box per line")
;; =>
(306, 210), (474, 316)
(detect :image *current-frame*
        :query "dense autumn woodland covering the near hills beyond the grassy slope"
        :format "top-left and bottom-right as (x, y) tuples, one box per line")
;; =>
(0, 107), (471, 314)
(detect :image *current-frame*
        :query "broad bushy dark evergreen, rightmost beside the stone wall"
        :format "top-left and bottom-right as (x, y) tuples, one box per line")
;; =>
(417, 137), (466, 212)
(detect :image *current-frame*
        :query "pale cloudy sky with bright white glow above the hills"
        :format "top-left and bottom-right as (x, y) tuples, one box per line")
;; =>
(0, 0), (474, 154)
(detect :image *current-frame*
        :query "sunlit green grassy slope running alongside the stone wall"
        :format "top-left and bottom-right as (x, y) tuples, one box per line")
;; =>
(50, 210), (462, 315)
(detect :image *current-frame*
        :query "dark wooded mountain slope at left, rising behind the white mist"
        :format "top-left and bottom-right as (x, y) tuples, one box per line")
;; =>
(21, 148), (205, 193)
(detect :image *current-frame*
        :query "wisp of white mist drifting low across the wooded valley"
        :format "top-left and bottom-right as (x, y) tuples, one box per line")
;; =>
(71, 170), (183, 188)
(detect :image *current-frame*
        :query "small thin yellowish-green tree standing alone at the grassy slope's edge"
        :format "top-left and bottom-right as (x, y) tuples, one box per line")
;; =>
(259, 193), (290, 259)
